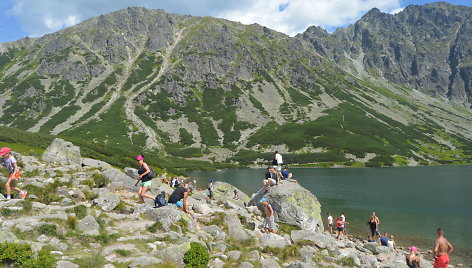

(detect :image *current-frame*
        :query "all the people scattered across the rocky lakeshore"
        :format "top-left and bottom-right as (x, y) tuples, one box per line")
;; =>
(0, 147), (454, 268)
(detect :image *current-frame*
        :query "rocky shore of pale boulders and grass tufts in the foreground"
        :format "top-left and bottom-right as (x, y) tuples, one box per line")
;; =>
(0, 139), (450, 268)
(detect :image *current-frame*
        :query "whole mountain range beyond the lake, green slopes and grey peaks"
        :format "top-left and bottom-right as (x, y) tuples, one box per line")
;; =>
(0, 4), (472, 166)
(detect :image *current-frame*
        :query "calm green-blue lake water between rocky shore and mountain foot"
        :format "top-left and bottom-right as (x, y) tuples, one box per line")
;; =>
(188, 166), (472, 263)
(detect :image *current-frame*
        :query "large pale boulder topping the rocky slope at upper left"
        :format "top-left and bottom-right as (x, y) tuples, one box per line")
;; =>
(42, 138), (82, 165)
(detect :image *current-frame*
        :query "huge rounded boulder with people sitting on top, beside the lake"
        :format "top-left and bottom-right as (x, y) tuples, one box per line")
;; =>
(249, 181), (324, 233)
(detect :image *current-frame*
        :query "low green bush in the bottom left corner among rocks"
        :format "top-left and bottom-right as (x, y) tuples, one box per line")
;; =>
(0, 243), (55, 268)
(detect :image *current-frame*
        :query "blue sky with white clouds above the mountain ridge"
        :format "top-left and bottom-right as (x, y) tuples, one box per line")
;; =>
(0, 0), (472, 43)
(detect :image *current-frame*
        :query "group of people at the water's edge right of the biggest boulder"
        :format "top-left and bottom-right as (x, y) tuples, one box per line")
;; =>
(327, 212), (454, 268)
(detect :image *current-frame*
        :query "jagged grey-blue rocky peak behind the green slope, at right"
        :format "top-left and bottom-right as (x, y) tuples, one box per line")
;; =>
(298, 2), (472, 108)
